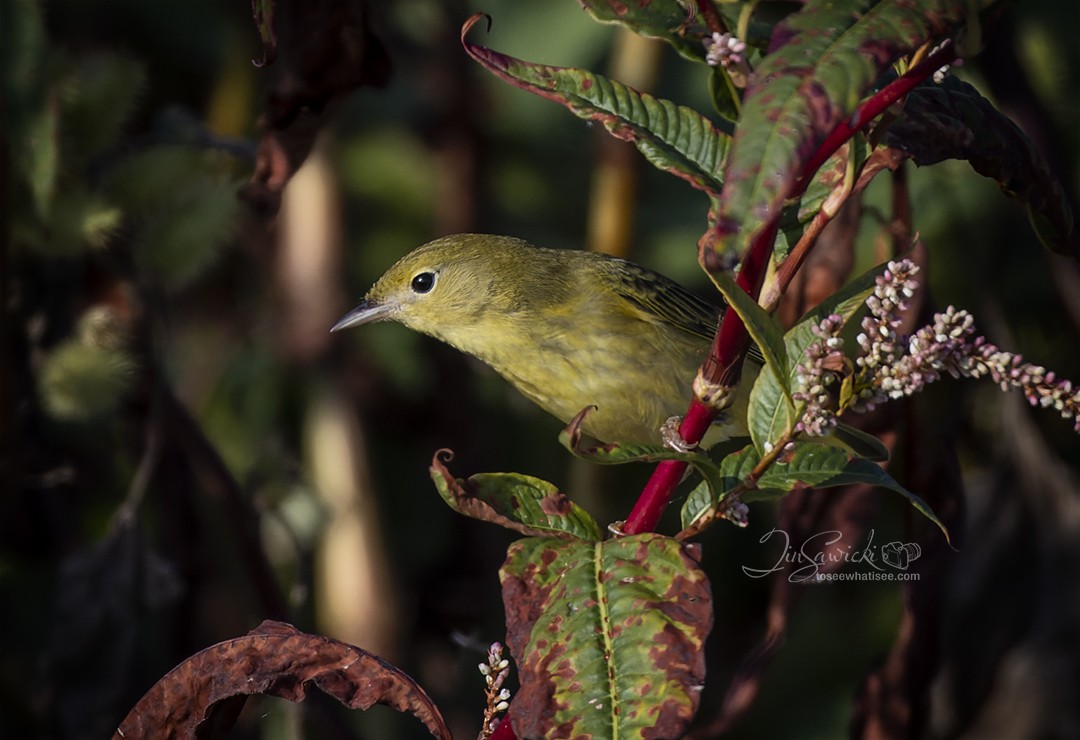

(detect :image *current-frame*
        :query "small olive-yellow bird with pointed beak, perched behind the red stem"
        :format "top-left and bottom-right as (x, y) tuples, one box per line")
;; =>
(330, 234), (747, 444)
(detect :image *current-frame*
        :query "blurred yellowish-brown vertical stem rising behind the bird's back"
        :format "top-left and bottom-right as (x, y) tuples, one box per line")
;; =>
(585, 28), (663, 257)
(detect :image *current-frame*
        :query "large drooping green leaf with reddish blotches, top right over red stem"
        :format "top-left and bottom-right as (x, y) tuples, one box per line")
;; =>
(716, 0), (968, 253)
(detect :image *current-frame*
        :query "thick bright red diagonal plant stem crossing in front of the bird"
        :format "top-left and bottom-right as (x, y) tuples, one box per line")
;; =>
(622, 44), (956, 535)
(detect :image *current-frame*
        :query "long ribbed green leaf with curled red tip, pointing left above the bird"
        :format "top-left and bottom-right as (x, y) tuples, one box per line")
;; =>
(461, 15), (729, 197)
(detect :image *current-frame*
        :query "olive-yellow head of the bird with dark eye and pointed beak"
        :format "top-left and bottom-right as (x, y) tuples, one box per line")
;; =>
(330, 234), (538, 339)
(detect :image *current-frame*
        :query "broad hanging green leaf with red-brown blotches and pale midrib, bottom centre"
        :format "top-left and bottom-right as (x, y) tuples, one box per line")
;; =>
(499, 534), (713, 738)
